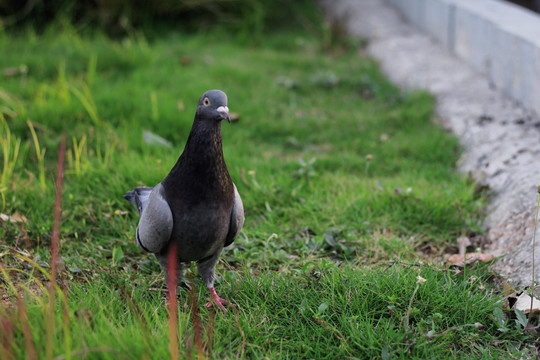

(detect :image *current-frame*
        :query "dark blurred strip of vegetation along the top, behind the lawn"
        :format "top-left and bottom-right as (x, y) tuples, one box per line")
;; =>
(0, 0), (321, 38)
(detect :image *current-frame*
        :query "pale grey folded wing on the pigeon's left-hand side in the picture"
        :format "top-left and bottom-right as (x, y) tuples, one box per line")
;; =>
(132, 184), (173, 253)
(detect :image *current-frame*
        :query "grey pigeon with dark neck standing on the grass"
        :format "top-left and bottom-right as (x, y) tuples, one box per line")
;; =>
(124, 90), (244, 310)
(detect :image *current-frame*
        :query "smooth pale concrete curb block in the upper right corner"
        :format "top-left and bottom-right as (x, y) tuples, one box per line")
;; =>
(389, 0), (540, 114)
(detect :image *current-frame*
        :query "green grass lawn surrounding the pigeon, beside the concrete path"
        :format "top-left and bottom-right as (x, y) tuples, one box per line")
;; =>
(0, 23), (533, 359)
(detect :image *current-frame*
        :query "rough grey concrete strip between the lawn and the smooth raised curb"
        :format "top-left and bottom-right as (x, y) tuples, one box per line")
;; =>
(321, 0), (540, 283)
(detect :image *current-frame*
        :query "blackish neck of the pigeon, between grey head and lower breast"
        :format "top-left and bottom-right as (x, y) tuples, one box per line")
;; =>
(163, 121), (232, 192)
